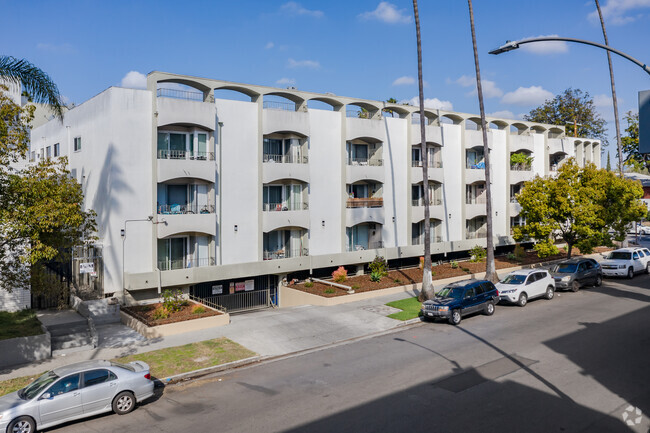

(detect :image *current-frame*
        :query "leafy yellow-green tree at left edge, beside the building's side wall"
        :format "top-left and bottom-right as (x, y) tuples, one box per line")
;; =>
(0, 86), (96, 293)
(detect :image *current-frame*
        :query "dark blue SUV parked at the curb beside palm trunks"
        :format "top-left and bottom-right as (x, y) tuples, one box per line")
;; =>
(422, 280), (499, 325)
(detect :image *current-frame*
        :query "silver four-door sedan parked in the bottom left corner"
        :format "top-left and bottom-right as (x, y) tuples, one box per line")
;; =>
(0, 360), (154, 433)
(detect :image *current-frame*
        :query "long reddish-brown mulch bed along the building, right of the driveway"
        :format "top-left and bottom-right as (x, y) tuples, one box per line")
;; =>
(288, 247), (612, 298)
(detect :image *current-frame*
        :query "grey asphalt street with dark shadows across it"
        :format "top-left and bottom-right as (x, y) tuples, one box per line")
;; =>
(48, 275), (650, 433)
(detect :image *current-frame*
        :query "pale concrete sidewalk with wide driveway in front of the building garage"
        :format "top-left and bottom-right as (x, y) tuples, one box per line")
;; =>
(0, 293), (415, 381)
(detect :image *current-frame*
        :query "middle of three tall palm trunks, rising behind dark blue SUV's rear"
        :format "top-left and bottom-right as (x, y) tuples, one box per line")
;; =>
(467, 0), (498, 282)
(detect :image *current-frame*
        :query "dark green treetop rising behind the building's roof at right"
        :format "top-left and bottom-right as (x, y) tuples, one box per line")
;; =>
(524, 88), (607, 146)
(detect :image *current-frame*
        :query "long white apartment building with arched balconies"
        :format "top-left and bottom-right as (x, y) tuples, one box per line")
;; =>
(30, 72), (600, 302)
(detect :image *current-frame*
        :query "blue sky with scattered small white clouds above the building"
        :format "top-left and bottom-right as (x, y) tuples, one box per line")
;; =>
(0, 0), (650, 164)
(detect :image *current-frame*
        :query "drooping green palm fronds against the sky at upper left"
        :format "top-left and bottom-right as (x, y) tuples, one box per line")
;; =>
(0, 56), (63, 119)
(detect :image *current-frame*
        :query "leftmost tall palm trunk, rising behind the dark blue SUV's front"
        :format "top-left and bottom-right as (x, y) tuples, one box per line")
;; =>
(413, 0), (434, 300)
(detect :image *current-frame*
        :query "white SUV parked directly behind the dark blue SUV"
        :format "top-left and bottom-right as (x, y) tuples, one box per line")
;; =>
(496, 269), (555, 307)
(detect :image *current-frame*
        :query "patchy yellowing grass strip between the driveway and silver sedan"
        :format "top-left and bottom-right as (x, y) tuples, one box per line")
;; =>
(114, 338), (255, 379)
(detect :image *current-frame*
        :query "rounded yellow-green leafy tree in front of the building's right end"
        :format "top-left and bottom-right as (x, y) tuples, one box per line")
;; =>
(513, 158), (647, 257)
